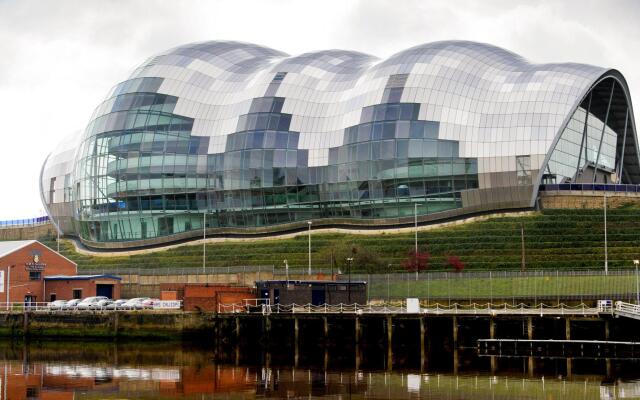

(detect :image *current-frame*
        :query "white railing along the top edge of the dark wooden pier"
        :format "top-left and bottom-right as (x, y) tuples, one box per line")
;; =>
(218, 301), (598, 315)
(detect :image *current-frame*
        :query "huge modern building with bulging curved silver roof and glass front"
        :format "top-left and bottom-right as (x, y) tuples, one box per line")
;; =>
(40, 41), (640, 248)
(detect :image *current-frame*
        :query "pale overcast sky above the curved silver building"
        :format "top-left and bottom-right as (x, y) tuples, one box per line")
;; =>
(0, 0), (640, 220)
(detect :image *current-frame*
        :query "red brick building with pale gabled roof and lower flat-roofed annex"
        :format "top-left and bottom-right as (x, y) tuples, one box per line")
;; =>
(0, 240), (120, 303)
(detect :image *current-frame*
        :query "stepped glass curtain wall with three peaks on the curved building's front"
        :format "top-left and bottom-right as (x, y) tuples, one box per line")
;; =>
(77, 93), (478, 241)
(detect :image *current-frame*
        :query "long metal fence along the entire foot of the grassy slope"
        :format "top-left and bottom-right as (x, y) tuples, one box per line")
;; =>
(78, 265), (640, 304)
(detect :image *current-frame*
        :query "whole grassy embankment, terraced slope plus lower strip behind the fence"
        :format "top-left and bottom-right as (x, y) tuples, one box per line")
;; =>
(32, 203), (640, 298)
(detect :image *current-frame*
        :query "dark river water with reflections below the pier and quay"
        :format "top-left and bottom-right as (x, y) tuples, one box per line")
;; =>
(0, 341), (640, 400)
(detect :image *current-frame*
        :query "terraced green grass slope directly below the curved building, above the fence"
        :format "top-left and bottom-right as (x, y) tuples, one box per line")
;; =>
(33, 206), (640, 272)
